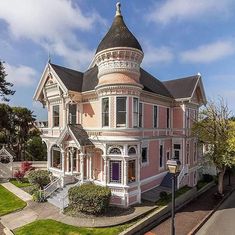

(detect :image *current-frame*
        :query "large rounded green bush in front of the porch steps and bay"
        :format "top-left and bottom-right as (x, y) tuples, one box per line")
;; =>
(69, 184), (111, 215)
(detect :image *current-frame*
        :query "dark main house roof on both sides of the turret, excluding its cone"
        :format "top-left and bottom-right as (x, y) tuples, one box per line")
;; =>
(51, 64), (198, 99)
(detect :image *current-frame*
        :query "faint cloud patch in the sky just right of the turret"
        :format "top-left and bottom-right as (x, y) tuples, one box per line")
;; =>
(143, 43), (174, 65)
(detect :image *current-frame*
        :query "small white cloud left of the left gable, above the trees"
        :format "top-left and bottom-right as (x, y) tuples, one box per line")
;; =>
(4, 63), (37, 87)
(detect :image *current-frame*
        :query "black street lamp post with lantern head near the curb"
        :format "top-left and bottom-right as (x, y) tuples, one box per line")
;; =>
(166, 158), (181, 235)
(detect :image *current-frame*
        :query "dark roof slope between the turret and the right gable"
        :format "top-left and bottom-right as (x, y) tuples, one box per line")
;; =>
(140, 68), (173, 98)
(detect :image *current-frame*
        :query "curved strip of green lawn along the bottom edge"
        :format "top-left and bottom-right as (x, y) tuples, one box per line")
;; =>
(14, 219), (128, 235)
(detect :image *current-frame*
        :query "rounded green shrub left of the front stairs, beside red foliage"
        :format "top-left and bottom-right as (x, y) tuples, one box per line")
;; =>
(28, 170), (50, 189)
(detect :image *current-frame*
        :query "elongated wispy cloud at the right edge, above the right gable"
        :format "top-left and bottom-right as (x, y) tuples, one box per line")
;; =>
(180, 41), (235, 63)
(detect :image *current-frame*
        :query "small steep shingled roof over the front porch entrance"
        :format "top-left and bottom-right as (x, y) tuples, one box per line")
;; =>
(68, 124), (93, 146)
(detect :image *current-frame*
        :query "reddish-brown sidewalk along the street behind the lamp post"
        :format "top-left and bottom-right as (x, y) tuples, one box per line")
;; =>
(145, 176), (235, 235)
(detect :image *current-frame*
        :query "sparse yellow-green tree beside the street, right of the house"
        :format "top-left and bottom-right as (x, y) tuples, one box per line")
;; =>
(193, 99), (235, 195)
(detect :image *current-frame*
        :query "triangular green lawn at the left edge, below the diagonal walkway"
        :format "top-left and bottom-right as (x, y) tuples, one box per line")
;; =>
(0, 185), (26, 216)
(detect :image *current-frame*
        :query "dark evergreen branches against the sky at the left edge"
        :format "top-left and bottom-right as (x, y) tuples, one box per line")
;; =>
(0, 60), (15, 101)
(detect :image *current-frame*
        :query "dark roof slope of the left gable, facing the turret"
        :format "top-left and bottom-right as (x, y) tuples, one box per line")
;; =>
(50, 63), (83, 92)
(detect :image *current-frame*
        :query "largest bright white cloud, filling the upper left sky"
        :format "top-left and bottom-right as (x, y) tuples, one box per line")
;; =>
(0, 0), (105, 68)
